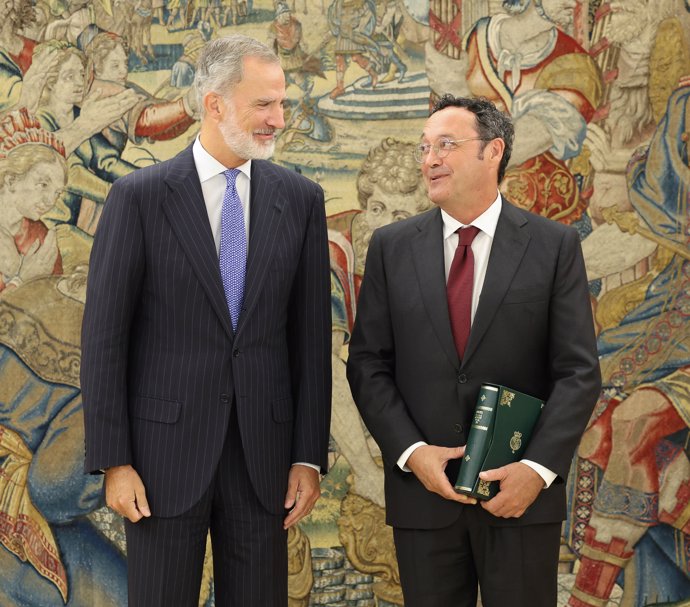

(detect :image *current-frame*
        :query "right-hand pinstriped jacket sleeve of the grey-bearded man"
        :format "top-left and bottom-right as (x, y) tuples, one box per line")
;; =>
(288, 187), (331, 473)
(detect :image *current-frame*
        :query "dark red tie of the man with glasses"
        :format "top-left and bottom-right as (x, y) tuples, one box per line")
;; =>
(446, 226), (479, 360)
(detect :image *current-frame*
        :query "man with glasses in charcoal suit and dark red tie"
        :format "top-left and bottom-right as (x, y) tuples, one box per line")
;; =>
(348, 96), (601, 607)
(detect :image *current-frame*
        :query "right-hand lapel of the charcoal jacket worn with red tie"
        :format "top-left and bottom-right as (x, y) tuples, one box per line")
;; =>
(463, 200), (530, 363)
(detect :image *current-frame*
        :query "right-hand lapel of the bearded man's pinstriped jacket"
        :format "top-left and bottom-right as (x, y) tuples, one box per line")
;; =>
(232, 160), (285, 333)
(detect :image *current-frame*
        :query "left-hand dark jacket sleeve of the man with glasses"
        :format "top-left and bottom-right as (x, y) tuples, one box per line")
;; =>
(347, 231), (426, 466)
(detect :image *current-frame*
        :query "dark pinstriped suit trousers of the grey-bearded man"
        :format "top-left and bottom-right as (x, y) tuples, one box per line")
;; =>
(125, 405), (287, 607)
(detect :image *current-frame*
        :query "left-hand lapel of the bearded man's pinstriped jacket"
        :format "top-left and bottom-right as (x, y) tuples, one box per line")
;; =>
(163, 146), (234, 339)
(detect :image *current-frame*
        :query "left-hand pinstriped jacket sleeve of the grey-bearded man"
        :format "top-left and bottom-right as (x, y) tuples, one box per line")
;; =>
(81, 181), (144, 472)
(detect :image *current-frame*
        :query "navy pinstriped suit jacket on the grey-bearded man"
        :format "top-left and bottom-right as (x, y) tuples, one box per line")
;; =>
(81, 147), (331, 516)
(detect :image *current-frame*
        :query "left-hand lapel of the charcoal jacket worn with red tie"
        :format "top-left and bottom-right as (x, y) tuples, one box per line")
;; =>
(411, 209), (460, 369)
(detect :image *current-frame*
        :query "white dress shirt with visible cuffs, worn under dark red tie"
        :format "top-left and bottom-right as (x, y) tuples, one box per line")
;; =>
(398, 194), (558, 487)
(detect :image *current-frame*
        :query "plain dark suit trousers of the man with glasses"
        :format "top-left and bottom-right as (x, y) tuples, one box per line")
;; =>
(393, 505), (561, 607)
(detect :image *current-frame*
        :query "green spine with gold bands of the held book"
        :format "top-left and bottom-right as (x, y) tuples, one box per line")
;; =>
(455, 385), (499, 493)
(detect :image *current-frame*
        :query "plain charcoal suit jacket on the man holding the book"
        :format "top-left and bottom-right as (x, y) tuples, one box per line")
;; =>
(348, 200), (601, 528)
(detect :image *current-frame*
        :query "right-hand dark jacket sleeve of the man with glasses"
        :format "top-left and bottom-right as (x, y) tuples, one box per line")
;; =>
(524, 229), (601, 482)
